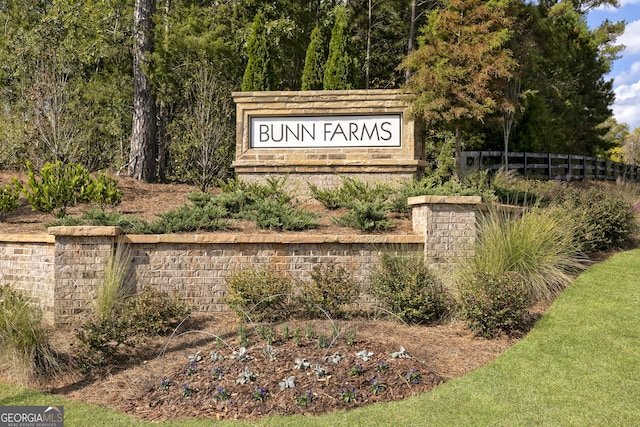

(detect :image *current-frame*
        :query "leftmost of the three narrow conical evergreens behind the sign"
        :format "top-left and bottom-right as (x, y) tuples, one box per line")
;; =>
(242, 12), (275, 92)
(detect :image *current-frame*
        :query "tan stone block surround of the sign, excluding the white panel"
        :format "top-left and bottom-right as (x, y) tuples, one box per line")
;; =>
(232, 90), (427, 194)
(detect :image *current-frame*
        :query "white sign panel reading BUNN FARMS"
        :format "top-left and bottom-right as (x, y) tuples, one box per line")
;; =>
(250, 114), (402, 148)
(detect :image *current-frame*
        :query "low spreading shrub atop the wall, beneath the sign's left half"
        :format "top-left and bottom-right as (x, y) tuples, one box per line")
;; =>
(238, 199), (318, 231)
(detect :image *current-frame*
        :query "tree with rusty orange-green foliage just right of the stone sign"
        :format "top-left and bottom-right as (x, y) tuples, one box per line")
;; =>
(403, 0), (517, 176)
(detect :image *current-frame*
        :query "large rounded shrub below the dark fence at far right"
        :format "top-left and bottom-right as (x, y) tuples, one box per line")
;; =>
(555, 187), (637, 254)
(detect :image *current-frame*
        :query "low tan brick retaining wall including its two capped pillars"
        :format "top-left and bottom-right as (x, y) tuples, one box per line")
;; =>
(0, 196), (500, 326)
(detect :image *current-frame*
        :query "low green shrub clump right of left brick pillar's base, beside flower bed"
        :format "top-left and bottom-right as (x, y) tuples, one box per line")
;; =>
(74, 287), (191, 374)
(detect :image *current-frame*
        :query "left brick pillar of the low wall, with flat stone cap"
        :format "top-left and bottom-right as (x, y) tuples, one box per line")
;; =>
(49, 227), (121, 326)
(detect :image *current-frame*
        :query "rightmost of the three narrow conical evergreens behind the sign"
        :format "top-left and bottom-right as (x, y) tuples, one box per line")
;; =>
(323, 5), (354, 90)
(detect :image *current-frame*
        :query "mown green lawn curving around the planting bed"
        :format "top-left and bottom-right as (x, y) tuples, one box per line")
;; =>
(0, 250), (640, 426)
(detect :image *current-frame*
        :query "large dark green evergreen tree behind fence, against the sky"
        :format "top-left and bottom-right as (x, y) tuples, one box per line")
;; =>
(514, 1), (619, 155)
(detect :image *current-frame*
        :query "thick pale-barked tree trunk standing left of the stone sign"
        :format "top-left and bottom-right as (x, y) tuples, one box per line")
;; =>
(129, 0), (156, 182)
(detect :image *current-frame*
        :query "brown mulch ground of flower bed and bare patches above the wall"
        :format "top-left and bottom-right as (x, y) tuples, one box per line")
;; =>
(0, 172), (518, 421)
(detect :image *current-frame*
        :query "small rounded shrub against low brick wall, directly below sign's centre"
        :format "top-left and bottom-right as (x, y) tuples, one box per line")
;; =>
(300, 261), (360, 318)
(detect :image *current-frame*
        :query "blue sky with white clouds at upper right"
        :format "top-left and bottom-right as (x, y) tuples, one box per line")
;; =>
(587, 0), (640, 131)
